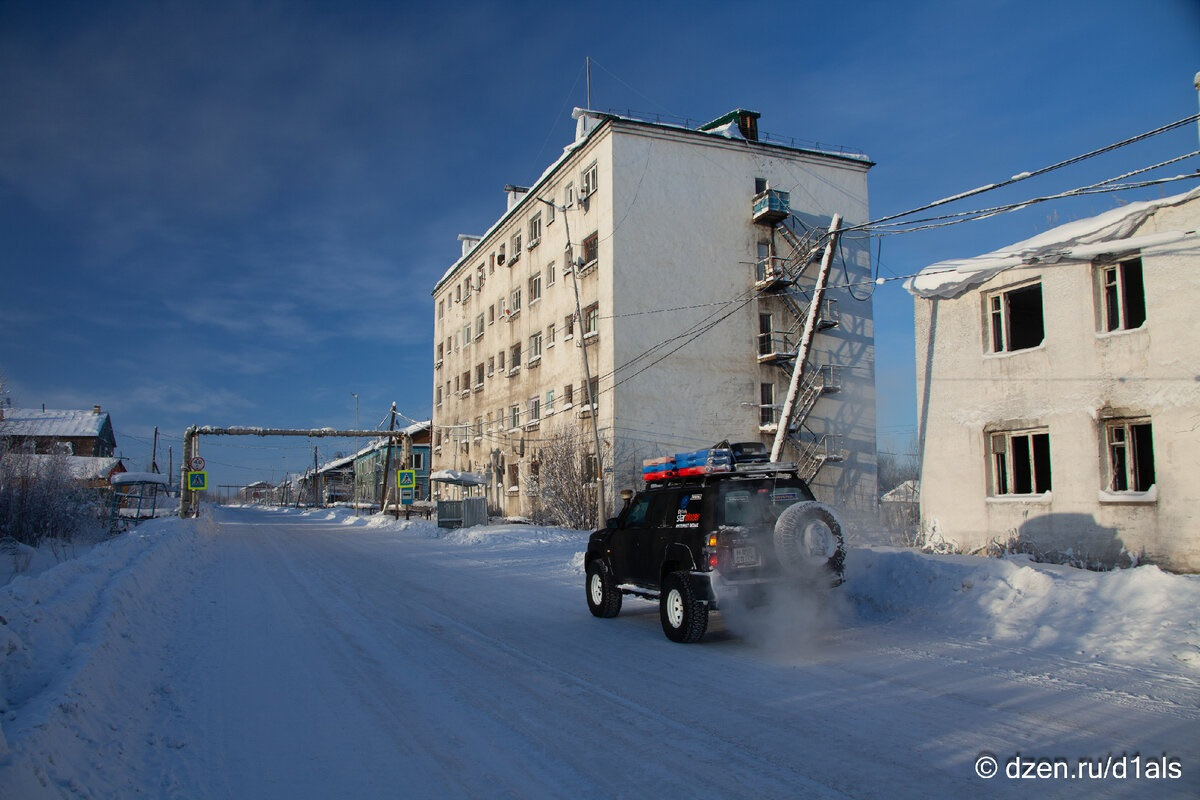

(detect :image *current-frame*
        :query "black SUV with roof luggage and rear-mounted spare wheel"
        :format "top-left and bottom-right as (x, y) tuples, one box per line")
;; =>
(584, 443), (846, 642)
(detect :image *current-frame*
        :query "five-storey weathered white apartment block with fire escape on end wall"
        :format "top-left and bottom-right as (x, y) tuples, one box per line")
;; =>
(432, 109), (876, 515)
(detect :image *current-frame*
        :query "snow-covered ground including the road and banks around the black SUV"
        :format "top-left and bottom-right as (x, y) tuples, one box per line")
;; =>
(0, 509), (1200, 798)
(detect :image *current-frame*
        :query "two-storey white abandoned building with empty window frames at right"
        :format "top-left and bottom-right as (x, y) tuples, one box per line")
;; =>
(908, 190), (1200, 572)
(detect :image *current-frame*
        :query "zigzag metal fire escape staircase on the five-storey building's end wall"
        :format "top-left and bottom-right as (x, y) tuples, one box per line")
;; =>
(752, 190), (845, 481)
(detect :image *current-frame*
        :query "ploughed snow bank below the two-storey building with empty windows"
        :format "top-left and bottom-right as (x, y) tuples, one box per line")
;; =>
(846, 548), (1200, 674)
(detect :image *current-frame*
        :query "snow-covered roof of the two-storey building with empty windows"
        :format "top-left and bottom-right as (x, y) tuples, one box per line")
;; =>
(905, 188), (1200, 297)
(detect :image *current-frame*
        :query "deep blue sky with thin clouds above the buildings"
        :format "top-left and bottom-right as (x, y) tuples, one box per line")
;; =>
(0, 0), (1200, 491)
